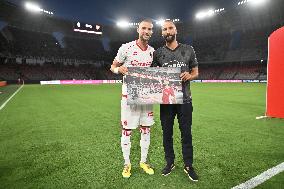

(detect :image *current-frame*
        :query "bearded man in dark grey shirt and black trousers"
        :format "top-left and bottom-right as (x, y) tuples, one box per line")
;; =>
(152, 20), (198, 181)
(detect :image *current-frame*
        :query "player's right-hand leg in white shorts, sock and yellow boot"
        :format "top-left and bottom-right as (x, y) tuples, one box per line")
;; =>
(140, 105), (154, 175)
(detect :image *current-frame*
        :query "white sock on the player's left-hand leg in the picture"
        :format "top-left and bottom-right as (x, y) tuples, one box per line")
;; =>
(121, 130), (131, 164)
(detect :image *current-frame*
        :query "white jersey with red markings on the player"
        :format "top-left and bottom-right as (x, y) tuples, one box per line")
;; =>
(115, 41), (154, 67)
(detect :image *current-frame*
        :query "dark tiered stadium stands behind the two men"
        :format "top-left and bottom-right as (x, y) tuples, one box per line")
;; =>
(0, 1), (284, 83)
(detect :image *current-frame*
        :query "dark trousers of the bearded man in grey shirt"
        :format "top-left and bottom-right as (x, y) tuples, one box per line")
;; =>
(160, 102), (193, 166)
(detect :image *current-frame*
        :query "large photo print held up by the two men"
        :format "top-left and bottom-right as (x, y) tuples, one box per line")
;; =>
(124, 67), (183, 104)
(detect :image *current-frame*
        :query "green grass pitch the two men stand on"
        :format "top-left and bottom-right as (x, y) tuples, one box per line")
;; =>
(0, 83), (284, 188)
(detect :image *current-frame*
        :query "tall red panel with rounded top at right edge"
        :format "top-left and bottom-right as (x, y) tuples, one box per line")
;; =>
(266, 27), (284, 118)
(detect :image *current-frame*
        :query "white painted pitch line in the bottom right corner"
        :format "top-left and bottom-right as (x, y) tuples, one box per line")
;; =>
(232, 162), (284, 189)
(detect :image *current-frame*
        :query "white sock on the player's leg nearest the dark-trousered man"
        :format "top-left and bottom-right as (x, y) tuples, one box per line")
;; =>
(140, 127), (150, 162)
